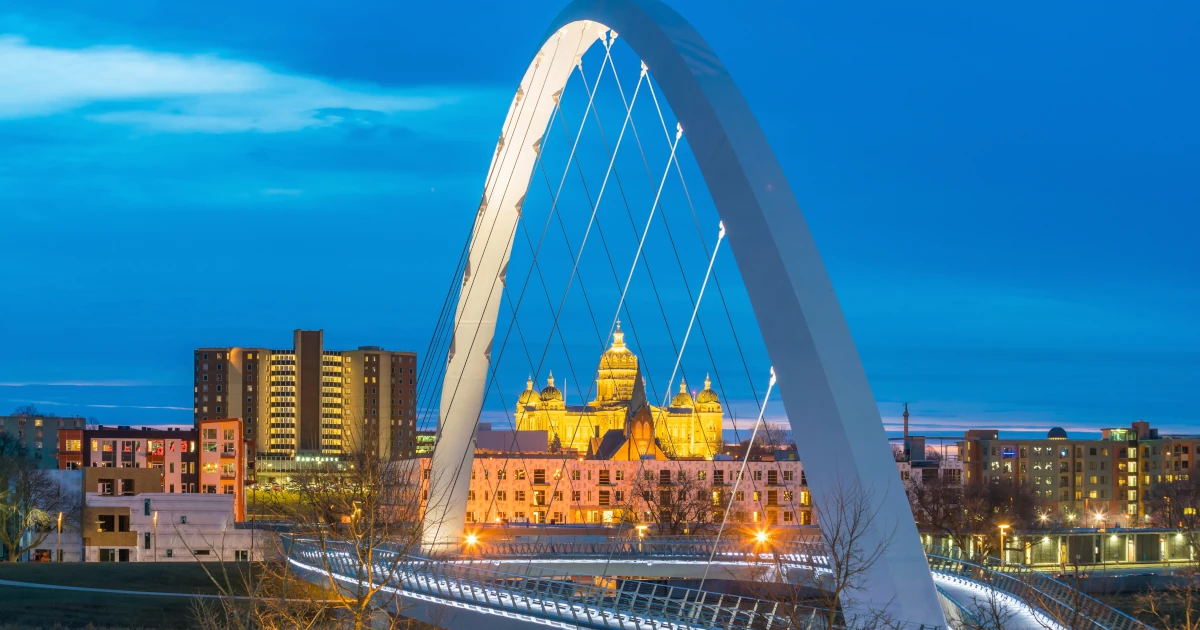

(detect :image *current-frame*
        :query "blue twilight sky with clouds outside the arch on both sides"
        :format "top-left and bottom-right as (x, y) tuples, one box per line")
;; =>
(0, 0), (1200, 433)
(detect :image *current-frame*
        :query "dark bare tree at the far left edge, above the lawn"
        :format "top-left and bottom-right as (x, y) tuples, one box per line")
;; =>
(0, 433), (80, 562)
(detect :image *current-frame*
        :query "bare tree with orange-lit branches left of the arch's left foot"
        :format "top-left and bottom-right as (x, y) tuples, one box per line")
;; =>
(198, 421), (436, 630)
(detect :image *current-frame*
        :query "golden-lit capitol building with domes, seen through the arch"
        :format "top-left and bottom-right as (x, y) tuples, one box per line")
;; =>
(514, 322), (722, 460)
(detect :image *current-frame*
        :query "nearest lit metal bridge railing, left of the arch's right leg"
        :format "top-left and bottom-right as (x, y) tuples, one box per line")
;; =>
(288, 540), (785, 630)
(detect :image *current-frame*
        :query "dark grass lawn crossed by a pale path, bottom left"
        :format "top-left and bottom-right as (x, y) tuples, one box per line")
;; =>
(0, 563), (245, 629)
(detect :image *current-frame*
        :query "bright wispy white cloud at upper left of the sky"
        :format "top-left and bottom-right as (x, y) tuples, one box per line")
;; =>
(0, 36), (494, 133)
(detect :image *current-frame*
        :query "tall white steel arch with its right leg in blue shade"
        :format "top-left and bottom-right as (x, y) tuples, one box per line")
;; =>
(425, 0), (946, 626)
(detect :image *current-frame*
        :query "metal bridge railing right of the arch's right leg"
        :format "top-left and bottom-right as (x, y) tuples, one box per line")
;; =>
(925, 546), (1150, 630)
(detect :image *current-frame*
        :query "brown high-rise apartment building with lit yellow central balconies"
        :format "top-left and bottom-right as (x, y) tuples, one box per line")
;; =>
(194, 330), (416, 458)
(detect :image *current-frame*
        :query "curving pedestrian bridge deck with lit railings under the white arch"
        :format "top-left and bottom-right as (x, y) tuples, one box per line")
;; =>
(288, 540), (1148, 630)
